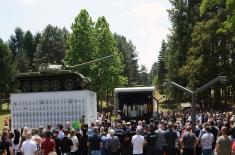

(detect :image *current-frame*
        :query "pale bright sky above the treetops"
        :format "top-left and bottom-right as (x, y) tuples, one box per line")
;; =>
(0, 0), (170, 70)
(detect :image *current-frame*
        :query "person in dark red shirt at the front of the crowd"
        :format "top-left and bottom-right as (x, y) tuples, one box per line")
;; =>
(41, 130), (56, 155)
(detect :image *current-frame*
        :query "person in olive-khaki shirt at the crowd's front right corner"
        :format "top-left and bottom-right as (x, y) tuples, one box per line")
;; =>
(216, 126), (231, 155)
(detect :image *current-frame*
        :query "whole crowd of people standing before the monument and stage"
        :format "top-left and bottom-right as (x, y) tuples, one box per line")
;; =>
(0, 110), (235, 155)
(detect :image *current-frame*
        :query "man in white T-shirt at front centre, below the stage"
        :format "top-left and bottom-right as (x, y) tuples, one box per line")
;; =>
(131, 128), (145, 155)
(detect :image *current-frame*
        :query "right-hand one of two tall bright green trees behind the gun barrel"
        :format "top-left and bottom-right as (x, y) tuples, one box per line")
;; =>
(92, 17), (126, 97)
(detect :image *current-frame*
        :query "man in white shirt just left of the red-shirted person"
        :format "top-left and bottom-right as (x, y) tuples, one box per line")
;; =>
(21, 132), (37, 155)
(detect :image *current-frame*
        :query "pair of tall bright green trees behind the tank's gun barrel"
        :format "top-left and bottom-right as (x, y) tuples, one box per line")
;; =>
(66, 10), (127, 103)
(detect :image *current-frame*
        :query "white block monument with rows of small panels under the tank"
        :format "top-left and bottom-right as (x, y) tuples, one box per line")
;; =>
(11, 90), (97, 129)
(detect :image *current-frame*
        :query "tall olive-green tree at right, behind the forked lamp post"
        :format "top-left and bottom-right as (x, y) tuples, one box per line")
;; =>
(181, 0), (229, 89)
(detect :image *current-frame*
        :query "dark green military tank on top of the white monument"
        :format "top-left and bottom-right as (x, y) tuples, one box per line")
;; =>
(13, 55), (112, 92)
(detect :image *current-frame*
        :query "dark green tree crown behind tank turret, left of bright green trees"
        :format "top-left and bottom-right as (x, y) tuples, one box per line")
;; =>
(36, 25), (68, 63)
